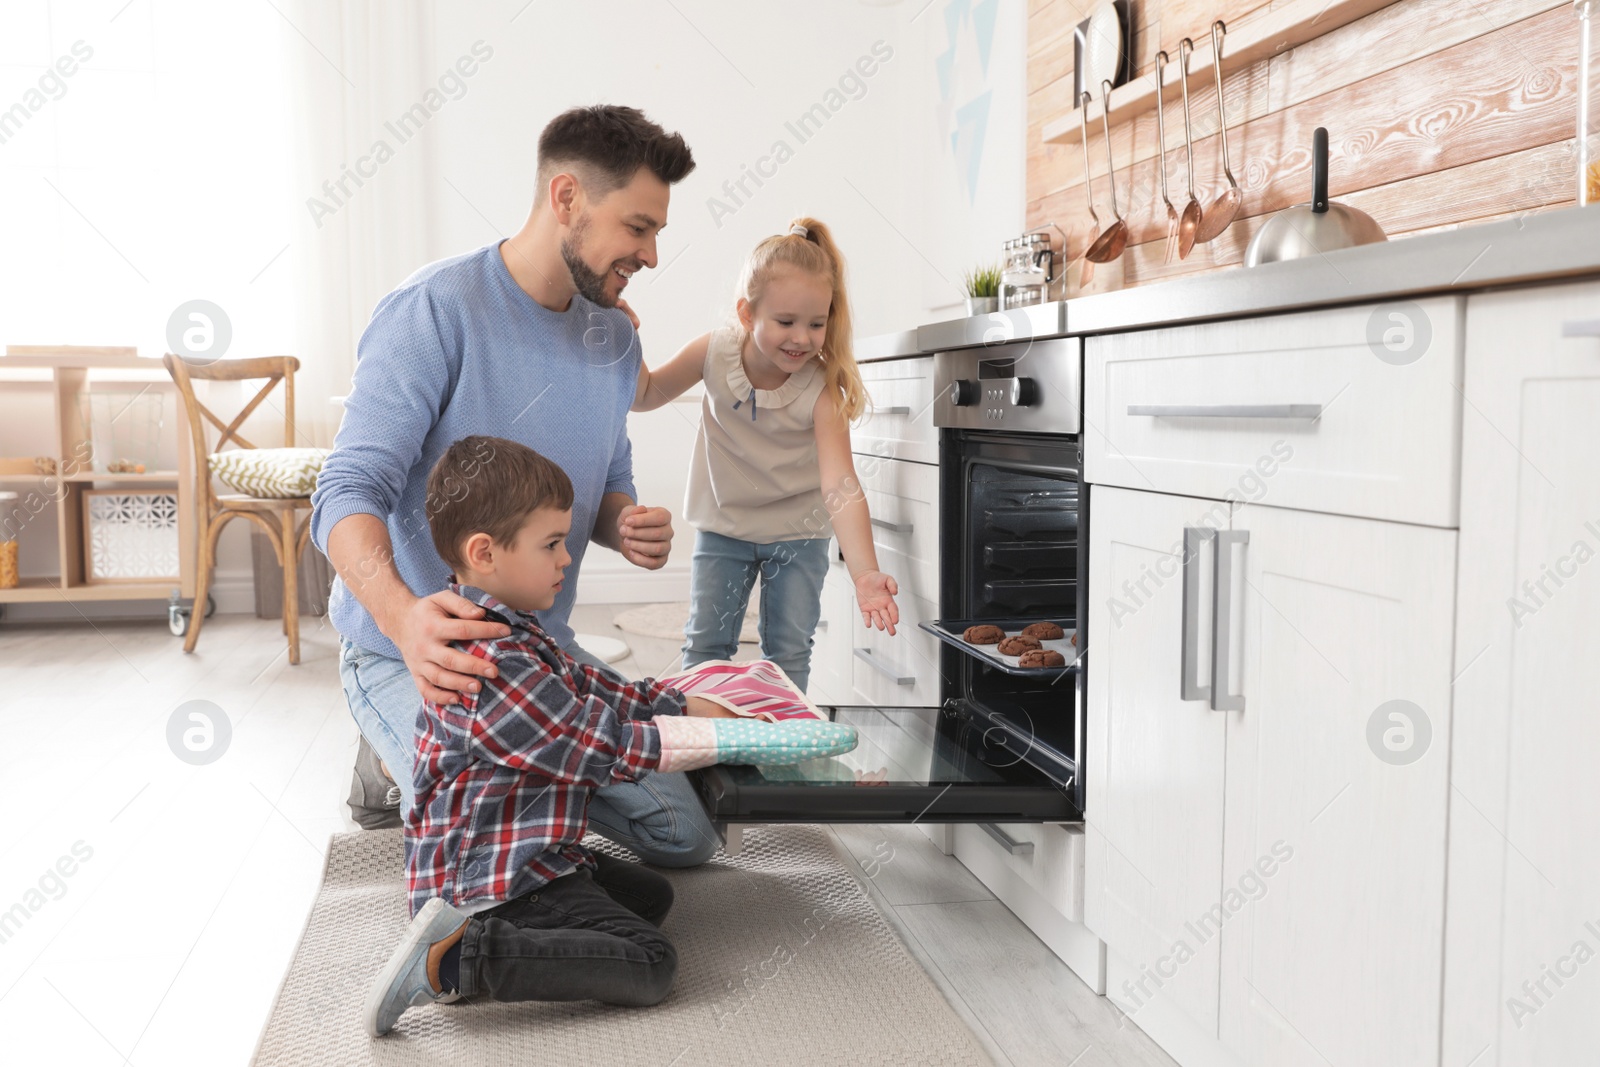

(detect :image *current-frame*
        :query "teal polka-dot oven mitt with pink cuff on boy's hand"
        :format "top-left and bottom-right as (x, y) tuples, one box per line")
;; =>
(650, 715), (856, 773)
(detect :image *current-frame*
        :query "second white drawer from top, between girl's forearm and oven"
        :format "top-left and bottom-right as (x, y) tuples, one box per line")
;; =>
(856, 458), (939, 603)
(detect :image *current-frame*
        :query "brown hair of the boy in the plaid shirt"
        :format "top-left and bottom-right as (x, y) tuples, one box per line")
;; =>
(427, 435), (573, 573)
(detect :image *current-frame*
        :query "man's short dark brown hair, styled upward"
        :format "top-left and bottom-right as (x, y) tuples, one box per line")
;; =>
(539, 104), (694, 198)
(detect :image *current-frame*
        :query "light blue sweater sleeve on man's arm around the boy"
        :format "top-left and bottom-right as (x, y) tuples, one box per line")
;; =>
(310, 286), (461, 555)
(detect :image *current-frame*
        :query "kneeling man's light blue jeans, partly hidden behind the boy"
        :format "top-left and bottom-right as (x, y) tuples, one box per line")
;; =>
(339, 641), (718, 867)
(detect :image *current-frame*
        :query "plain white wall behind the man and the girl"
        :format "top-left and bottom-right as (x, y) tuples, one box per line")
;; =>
(434, 0), (1026, 601)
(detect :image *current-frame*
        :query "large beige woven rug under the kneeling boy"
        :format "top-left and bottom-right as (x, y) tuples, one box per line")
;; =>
(253, 825), (990, 1067)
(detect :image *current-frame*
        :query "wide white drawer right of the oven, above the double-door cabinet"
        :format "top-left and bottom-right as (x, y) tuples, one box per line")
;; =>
(1085, 296), (1464, 528)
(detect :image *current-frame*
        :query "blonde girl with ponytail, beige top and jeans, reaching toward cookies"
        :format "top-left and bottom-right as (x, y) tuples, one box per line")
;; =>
(634, 218), (899, 691)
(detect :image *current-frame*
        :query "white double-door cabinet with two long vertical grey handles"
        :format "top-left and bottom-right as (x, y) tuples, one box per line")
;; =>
(1085, 486), (1456, 1067)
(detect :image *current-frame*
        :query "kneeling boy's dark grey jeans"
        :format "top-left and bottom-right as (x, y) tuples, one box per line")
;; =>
(459, 853), (678, 1006)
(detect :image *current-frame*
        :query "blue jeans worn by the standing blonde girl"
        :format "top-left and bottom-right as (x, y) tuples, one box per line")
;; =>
(683, 530), (827, 693)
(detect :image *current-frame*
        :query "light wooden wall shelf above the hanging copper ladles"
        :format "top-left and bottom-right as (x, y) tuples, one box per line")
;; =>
(1043, 0), (1394, 144)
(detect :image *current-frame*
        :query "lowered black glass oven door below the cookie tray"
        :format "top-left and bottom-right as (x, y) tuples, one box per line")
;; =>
(690, 701), (1083, 830)
